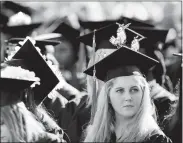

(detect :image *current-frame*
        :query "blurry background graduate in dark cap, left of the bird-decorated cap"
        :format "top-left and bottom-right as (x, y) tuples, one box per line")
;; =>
(38, 17), (84, 91)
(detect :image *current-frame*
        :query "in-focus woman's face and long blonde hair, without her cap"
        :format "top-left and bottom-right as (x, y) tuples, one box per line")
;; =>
(85, 71), (173, 142)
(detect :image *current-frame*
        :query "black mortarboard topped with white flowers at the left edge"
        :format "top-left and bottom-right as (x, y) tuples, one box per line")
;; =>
(0, 59), (40, 92)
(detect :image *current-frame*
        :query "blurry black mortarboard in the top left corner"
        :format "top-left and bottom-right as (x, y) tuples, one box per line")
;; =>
(2, 1), (33, 15)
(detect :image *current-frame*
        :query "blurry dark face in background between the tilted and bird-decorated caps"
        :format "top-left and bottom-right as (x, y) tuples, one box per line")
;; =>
(54, 41), (75, 69)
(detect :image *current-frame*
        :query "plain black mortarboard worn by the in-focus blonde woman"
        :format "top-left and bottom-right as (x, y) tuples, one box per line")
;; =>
(84, 46), (158, 81)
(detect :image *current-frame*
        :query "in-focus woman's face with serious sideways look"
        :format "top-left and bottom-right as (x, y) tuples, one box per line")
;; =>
(109, 76), (143, 118)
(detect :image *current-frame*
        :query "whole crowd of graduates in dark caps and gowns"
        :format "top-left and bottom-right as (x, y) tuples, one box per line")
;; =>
(0, 1), (183, 143)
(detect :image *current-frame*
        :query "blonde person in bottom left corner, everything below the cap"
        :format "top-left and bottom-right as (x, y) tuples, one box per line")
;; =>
(1, 102), (60, 142)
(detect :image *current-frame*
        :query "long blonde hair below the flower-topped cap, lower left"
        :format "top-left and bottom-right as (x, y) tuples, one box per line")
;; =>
(1, 102), (45, 142)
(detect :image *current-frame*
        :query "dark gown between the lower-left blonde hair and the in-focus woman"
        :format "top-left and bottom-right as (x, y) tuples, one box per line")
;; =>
(58, 95), (91, 142)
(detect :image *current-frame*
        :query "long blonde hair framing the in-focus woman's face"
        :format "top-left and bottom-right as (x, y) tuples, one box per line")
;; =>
(84, 76), (163, 142)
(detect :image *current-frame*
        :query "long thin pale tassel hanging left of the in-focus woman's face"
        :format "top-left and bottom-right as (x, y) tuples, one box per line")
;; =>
(91, 30), (97, 123)
